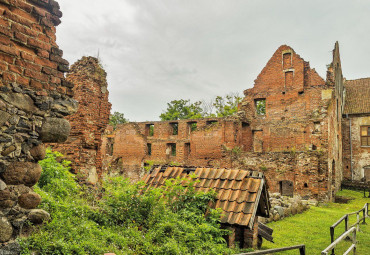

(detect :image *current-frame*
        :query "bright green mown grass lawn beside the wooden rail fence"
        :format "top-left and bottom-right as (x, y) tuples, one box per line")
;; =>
(262, 190), (370, 255)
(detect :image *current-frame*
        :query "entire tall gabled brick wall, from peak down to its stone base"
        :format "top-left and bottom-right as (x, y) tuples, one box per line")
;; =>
(239, 45), (341, 199)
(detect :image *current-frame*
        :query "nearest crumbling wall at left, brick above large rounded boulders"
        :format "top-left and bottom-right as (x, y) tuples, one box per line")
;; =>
(0, 0), (77, 250)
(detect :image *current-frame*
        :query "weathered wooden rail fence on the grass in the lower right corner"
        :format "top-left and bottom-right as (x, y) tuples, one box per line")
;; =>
(321, 203), (369, 255)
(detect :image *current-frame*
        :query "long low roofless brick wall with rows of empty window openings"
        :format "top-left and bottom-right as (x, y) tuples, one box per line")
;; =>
(103, 118), (248, 180)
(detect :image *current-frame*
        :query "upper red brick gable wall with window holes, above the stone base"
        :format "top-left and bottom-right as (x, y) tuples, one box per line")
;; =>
(241, 46), (327, 152)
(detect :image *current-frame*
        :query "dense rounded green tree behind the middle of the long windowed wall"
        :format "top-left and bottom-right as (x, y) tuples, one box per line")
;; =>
(159, 99), (203, 120)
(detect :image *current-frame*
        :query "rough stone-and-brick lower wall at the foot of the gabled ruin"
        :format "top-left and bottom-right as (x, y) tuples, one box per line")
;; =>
(233, 151), (328, 200)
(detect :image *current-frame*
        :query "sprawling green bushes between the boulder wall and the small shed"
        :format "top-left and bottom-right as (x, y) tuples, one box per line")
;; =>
(20, 151), (231, 255)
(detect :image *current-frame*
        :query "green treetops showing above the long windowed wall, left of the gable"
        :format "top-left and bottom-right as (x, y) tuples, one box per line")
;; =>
(159, 93), (242, 120)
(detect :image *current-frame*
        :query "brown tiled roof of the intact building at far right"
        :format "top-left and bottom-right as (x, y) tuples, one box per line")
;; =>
(343, 78), (370, 114)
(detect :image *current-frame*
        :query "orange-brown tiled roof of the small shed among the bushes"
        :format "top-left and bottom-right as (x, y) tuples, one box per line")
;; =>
(144, 167), (269, 228)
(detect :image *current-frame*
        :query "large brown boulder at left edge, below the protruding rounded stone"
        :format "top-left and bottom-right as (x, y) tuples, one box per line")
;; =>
(1, 162), (42, 187)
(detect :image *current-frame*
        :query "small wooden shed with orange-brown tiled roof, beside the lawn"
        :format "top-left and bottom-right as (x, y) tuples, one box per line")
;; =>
(143, 166), (272, 248)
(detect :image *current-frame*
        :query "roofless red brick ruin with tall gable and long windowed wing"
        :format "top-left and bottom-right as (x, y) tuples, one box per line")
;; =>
(102, 43), (370, 199)
